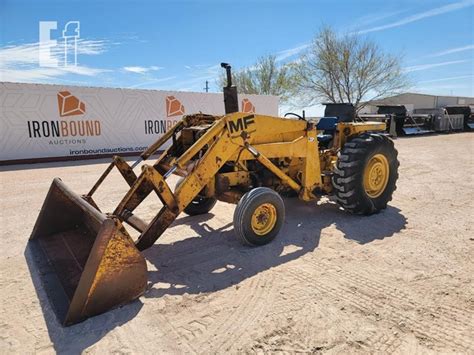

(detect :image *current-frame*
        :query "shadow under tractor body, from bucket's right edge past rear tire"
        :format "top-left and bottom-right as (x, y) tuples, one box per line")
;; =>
(145, 199), (406, 297)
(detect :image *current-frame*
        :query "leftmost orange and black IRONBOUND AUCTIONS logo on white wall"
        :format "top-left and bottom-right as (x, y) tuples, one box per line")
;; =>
(27, 91), (102, 144)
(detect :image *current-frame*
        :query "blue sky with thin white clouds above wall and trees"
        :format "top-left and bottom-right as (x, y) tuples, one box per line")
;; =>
(0, 0), (474, 108)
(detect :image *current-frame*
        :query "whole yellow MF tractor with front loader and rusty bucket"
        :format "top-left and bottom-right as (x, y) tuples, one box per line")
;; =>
(29, 63), (399, 325)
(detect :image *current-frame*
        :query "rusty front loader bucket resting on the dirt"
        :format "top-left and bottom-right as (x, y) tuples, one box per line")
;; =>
(29, 179), (147, 325)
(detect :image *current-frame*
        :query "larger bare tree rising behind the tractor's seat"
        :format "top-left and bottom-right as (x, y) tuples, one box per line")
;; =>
(293, 27), (409, 109)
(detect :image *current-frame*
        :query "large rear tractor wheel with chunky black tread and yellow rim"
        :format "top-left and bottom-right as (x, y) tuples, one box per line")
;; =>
(332, 133), (400, 215)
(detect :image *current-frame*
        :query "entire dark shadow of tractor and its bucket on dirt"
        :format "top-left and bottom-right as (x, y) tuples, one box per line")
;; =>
(25, 198), (406, 354)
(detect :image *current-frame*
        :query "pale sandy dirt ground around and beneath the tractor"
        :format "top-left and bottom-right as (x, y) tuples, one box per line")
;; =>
(0, 133), (474, 354)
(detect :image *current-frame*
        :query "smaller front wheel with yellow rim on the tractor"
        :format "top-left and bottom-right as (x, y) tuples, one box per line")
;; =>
(234, 187), (285, 245)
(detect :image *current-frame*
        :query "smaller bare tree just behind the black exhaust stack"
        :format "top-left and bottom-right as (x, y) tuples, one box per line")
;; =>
(218, 55), (294, 102)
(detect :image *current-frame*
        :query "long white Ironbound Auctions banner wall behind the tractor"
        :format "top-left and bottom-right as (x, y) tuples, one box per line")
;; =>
(0, 83), (278, 163)
